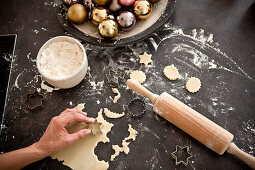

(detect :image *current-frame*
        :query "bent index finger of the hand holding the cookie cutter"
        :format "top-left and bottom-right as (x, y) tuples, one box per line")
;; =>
(60, 109), (93, 127)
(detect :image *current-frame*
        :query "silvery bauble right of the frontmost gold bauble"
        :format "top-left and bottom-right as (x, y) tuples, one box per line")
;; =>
(117, 11), (136, 31)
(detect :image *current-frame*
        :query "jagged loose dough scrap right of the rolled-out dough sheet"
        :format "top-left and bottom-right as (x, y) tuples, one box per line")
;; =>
(110, 124), (138, 161)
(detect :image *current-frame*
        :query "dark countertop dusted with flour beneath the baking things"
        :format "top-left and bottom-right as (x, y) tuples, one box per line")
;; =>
(0, 0), (255, 169)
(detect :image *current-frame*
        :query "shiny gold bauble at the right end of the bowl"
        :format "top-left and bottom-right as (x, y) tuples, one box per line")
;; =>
(134, 0), (152, 19)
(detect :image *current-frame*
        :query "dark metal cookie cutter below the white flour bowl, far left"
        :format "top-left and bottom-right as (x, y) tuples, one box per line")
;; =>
(25, 91), (44, 110)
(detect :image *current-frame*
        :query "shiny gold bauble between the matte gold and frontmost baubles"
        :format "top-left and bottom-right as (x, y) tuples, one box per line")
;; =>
(91, 7), (109, 25)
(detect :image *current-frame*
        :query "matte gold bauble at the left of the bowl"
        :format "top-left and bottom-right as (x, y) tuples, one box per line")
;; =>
(67, 4), (88, 24)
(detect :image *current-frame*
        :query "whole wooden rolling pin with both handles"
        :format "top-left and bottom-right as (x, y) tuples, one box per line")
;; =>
(127, 79), (255, 169)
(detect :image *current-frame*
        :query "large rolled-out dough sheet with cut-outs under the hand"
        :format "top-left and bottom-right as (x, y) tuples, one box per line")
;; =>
(51, 109), (113, 170)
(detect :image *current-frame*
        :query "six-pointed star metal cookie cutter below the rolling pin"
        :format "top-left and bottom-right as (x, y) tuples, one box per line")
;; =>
(171, 145), (193, 166)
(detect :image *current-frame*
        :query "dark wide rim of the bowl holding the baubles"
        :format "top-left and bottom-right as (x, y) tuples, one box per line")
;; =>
(54, 0), (176, 47)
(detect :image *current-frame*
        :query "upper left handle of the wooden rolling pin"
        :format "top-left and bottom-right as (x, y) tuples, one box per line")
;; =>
(127, 79), (158, 104)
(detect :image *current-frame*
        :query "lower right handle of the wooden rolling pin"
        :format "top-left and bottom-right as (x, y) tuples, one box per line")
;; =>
(227, 143), (255, 169)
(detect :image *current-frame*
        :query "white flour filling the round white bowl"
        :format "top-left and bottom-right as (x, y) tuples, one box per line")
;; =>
(39, 41), (84, 79)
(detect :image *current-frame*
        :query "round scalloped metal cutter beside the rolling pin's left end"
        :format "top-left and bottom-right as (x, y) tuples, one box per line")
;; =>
(127, 98), (145, 118)
